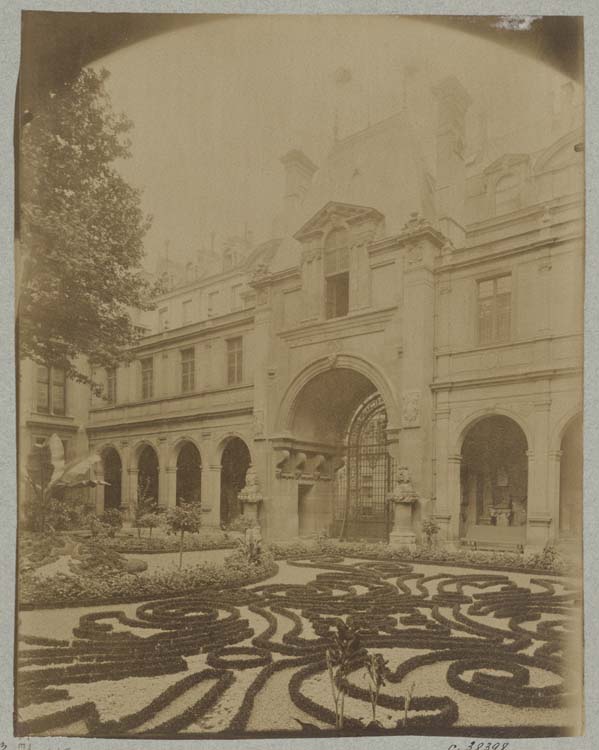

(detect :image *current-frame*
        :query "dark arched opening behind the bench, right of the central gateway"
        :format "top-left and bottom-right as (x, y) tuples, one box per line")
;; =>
(460, 415), (528, 544)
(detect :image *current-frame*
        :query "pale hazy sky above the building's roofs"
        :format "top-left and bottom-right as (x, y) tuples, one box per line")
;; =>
(96, 15), (580, 268)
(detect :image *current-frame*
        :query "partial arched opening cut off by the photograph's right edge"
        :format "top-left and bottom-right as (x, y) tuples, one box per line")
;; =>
(559, 415), (583, 540)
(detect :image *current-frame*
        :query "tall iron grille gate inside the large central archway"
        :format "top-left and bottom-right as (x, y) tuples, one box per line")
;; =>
(335, 394), (393, 541)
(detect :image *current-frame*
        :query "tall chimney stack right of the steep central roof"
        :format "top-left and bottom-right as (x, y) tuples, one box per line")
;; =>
(433, 76), (472, 244)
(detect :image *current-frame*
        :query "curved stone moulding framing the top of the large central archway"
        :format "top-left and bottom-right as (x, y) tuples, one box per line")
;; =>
(275, 352), (401, 434)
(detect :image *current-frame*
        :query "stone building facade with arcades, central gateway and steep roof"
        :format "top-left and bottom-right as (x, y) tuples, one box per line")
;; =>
(19, 79), (584, 548)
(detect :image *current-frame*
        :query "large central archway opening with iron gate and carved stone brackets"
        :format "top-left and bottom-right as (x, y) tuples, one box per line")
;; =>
(288, 366), (392, 541)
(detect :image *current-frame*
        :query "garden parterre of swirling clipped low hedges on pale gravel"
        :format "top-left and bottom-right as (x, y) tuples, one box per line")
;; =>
(17, 554), (580, 737)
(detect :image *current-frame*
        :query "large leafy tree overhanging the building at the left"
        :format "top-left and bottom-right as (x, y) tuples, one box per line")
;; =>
(17, 69), (158, 392)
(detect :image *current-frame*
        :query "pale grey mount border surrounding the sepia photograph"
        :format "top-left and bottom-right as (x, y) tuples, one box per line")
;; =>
(0, 0), (599, 750)
